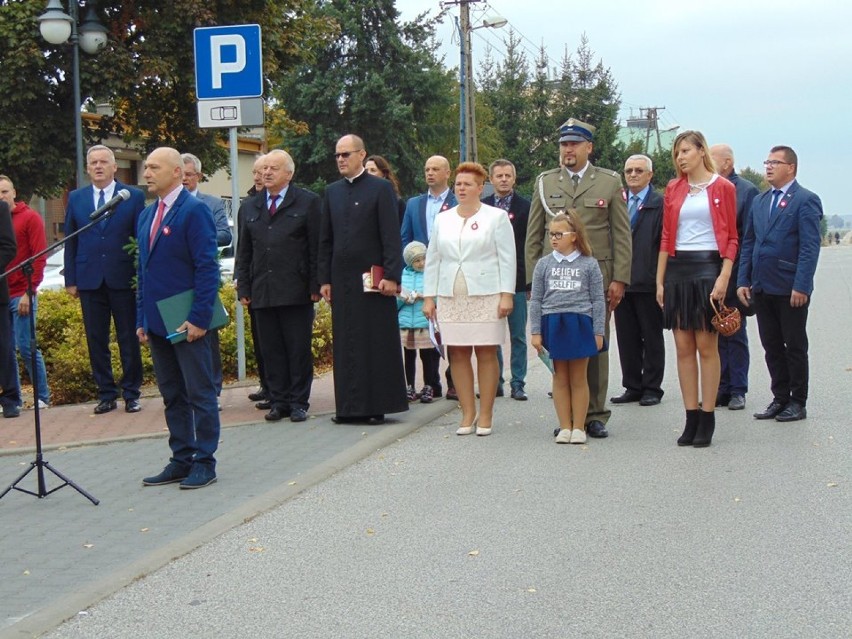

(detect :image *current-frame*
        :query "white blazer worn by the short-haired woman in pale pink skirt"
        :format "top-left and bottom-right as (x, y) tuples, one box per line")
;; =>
(423, 204), (517, 297)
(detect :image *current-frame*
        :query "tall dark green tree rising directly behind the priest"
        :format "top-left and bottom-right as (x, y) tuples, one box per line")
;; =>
(273, 0), (458, 192)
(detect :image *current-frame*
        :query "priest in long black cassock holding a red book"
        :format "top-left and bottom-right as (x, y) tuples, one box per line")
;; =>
(317, 135), (408, 424)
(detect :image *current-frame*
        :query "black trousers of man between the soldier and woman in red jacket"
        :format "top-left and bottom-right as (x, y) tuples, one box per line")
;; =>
(615, 292), (666, 397)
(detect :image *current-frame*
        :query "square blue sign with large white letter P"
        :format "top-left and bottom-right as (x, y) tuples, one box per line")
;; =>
(193, 24), (263, 100)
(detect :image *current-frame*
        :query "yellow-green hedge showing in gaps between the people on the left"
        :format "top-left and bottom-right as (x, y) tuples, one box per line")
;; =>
(33, 284), (332, 404)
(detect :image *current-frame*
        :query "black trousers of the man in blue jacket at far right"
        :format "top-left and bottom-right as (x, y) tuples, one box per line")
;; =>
(754, 293), (810, 406)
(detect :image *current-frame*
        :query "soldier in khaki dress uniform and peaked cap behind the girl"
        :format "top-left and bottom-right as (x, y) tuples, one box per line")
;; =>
(526, 118), (633, 437)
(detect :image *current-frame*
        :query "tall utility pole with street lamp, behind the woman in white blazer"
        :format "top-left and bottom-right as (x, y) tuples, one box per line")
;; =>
(444, 0), (509, 162)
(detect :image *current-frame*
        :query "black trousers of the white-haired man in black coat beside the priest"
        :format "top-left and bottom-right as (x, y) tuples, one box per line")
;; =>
(254, 303), (314, 411)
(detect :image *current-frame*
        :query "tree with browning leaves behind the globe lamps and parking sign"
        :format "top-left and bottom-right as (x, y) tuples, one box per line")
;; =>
(0, 0), (334, 196)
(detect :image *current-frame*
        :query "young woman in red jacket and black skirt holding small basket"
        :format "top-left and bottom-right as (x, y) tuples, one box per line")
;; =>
(657, 131), (738, 448)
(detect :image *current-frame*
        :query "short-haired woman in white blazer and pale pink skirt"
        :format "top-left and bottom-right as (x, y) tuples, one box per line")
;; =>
(423, 162), (517, 435)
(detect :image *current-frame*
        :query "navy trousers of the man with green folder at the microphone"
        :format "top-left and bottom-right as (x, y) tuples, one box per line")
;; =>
(148, 332), (219, 470)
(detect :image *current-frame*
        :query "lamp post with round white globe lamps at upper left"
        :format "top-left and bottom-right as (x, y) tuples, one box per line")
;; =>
(38, 0), (107, 188)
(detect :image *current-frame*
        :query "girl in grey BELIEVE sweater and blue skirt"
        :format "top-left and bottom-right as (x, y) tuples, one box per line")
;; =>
(529, 209), (606, 444)
